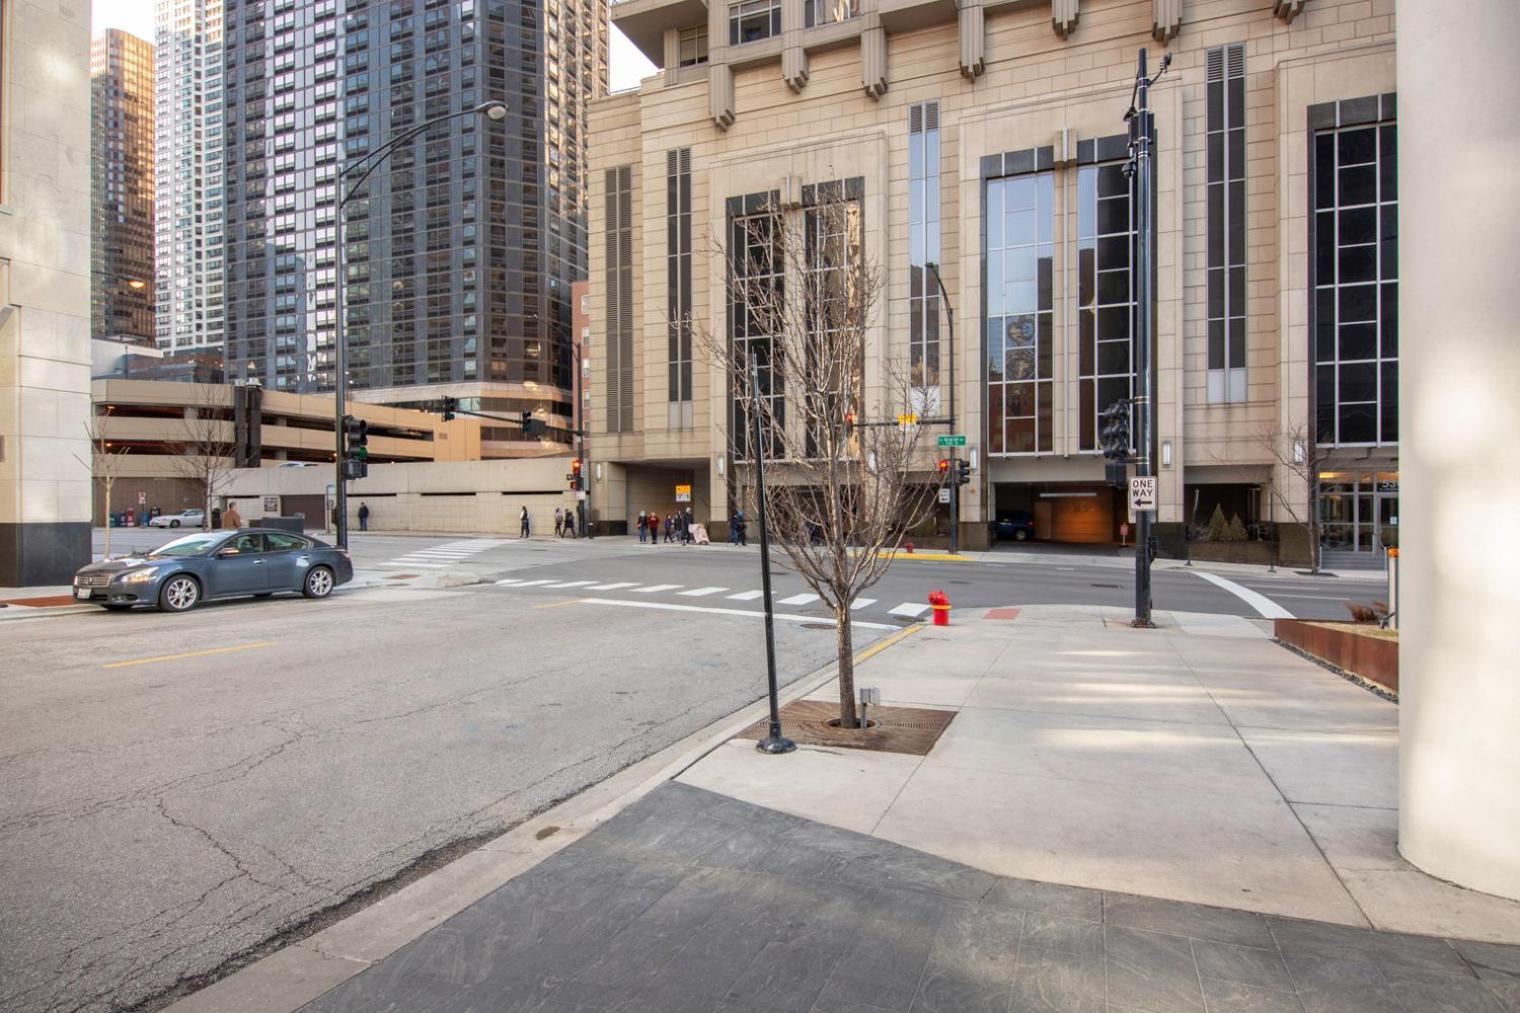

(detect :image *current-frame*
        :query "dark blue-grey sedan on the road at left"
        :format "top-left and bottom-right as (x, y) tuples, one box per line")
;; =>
(74, 528), (354, 611)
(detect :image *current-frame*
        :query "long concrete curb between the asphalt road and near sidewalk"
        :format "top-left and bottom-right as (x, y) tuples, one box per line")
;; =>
(166, 614), (924, 1013)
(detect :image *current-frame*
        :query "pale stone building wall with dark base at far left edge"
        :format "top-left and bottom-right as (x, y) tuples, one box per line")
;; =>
(0, 3), (90, 586)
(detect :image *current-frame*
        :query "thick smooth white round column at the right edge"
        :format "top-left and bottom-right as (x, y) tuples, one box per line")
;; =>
(1397, 0), (1520, 899)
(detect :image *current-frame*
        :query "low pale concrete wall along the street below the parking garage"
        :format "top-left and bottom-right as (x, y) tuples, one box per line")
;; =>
(223, 456), (576, 535)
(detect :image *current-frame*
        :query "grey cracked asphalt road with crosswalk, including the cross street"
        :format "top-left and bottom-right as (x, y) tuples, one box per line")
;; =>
(0, 531), (1382, 1011)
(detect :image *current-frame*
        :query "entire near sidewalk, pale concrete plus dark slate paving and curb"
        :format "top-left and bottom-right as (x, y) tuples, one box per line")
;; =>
(166, 607), (1520, 1013)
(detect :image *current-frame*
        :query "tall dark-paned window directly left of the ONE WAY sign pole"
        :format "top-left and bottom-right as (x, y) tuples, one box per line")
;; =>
(1076, 161), (1135, 450)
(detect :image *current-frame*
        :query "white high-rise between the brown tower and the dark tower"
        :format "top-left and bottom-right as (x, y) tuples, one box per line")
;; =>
(154, 0), (225, 350)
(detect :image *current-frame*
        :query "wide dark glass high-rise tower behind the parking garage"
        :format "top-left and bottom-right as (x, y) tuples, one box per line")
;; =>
(225, 0), (608, 440)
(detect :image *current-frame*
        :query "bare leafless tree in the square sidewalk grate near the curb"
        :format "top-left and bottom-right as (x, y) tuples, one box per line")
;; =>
(696, 191), (941, 727)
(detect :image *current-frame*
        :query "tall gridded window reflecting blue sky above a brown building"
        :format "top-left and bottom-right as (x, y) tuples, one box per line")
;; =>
(985, 172), (1055, 455)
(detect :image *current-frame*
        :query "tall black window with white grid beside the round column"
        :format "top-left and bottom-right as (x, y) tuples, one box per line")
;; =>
(1313, 116), (1398, 446)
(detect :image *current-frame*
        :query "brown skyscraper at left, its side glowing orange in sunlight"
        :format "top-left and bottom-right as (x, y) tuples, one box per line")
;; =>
(90, 29), (154, 342)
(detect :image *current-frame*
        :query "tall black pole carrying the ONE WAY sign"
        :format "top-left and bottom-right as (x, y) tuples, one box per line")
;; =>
(1131, 49), (1166, 627)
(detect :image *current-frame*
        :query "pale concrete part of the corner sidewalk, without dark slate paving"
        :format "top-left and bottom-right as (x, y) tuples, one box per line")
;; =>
(681, 605), (1520, 943)
